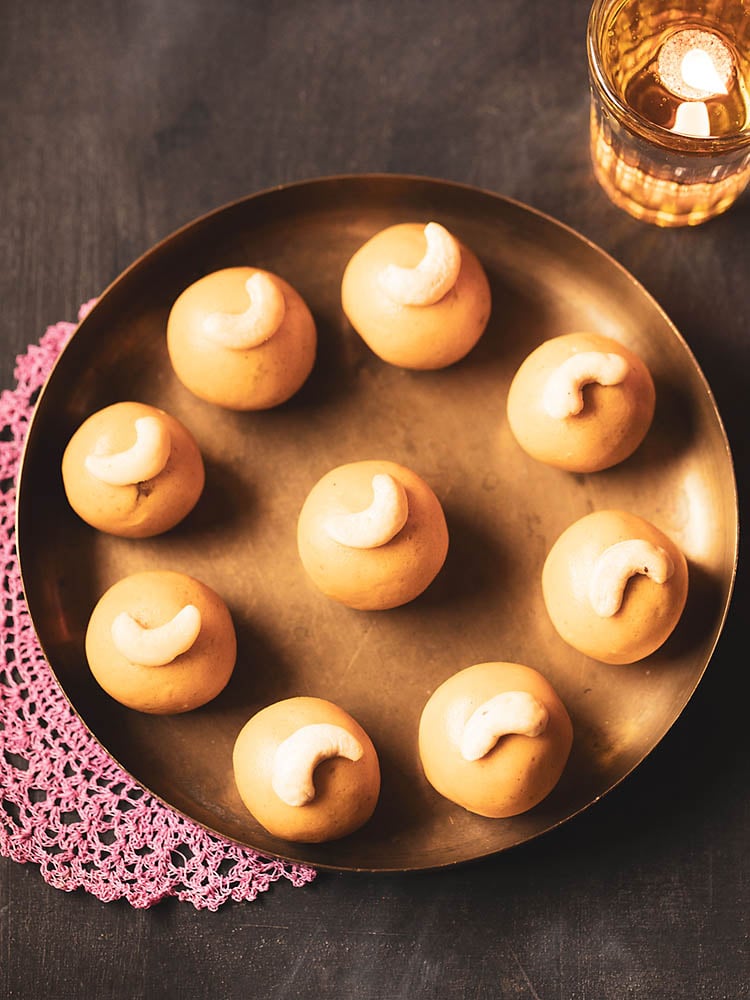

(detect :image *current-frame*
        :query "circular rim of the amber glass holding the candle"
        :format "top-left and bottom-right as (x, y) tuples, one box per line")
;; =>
(586, 0), (750, 155)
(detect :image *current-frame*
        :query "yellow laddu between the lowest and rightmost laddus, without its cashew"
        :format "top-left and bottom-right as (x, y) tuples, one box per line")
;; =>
(419, 662), (573, 818)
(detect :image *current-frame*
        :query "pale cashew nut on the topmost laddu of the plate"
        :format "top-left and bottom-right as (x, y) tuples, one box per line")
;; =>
(378, 222), (461, 306)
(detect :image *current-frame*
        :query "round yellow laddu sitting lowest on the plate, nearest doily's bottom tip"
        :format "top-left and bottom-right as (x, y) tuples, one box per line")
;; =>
(232, 697), (380, 843)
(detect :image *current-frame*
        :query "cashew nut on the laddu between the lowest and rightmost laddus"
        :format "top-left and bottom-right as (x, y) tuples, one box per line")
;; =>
(459, 691), (549, 761)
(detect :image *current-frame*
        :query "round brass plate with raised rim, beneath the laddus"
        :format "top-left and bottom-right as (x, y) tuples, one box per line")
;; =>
(18, 175), (738, 871)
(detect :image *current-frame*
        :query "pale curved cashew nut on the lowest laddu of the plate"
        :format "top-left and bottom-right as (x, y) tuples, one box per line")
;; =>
(271, 722), (364, 806)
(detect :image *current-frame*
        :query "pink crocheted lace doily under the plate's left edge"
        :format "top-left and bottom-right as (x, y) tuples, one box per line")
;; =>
(0, 303), (315, 910)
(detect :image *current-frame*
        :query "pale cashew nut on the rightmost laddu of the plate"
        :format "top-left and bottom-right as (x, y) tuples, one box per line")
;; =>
(589, 538), (674, 618)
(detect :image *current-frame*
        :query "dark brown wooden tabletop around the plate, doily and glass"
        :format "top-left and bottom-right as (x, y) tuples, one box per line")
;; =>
(0, 0), (750, 1000)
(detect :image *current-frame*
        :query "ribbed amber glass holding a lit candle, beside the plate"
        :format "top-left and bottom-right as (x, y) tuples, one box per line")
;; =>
(587, 0), (750, 226)
